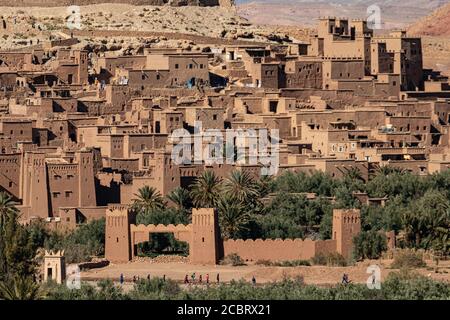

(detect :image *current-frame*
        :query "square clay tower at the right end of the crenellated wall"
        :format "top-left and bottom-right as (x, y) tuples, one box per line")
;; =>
(333, 209), (361, 258)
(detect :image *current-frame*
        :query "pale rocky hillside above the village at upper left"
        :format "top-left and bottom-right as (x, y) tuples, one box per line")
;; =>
(0, 4), (284, 50)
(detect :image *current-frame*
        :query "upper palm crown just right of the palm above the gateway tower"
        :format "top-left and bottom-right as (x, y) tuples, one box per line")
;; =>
(223, 170), (259, 205)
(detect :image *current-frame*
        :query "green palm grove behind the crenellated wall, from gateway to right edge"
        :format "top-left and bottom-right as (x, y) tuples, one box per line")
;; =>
(134, 167), (450, 259)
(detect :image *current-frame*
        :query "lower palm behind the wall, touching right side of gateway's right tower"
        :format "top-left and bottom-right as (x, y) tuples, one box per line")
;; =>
(218, 196), (250, 239)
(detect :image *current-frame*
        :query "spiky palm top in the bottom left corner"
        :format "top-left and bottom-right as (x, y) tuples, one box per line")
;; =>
(0, 276), (44, 300)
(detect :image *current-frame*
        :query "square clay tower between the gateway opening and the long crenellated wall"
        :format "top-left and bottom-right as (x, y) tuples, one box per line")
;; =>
(189, 208), (219, 265)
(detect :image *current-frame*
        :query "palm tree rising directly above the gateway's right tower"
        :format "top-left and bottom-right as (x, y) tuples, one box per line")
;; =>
(190, 171), (221, 208)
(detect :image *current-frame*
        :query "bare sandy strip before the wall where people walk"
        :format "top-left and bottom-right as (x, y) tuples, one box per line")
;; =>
(81, 260), (450, 285)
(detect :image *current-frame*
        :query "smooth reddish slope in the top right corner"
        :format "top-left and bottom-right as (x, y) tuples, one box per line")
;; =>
(408, 3), (450, 36)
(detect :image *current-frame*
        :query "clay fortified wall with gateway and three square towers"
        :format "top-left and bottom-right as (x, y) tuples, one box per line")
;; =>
(105, 206), (361, 265)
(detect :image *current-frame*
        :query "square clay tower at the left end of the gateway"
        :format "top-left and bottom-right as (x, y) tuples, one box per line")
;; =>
(105, 205), (135, 262)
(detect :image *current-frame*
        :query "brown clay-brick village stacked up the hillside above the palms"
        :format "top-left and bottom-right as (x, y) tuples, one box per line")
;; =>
(0, 18), (450, 226)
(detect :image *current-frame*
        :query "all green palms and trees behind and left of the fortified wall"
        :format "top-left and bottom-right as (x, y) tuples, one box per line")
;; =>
(0, 167), (450, 298)
